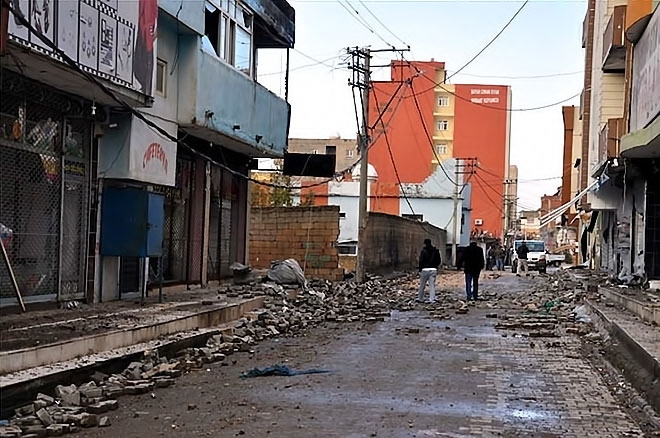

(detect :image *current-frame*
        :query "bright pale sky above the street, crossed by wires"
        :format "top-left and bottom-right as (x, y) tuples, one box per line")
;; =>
(258, 0), (587, 209)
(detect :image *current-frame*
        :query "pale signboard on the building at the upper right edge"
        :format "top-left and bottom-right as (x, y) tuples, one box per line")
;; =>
(630, 9), (660, 131)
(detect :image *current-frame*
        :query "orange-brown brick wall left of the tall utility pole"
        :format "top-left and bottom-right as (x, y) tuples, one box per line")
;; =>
(249, 206), (344, 281)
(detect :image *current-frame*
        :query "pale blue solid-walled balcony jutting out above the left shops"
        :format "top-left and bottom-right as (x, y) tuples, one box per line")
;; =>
(178, 44), (290, 157)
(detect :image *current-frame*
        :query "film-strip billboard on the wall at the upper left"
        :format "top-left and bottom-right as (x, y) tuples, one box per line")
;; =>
(9, 0), (158, 95)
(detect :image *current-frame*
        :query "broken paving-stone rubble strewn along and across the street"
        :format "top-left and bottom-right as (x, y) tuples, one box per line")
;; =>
(0, 268), (620, 438)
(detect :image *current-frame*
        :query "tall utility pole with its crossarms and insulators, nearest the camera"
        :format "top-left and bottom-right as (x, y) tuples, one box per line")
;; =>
(347, 47), (410, 283)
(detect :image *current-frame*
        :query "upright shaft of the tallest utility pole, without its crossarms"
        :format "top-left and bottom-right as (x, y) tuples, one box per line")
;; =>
(356, 48), (371, 283)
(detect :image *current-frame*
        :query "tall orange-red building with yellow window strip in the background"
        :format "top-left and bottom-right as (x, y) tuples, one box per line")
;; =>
(369, 61), (511, 237)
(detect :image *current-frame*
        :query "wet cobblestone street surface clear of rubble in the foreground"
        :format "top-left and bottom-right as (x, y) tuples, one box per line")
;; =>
(81, 275), (645, 438)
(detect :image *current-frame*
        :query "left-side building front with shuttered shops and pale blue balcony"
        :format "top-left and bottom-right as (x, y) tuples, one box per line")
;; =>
(0, 0), (295, 308)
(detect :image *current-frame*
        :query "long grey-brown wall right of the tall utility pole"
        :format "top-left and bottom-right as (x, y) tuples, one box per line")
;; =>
(365, 212), (448, 272)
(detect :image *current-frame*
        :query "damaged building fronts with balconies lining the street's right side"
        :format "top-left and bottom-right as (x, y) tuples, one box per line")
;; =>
(544, 0), (660, 282)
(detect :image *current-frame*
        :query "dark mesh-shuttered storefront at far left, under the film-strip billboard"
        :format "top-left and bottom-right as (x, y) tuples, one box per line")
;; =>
(0, 70), (92, 305)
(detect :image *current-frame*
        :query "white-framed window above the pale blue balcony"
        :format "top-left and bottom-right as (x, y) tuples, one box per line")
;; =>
(204, 0), (254, 76)
